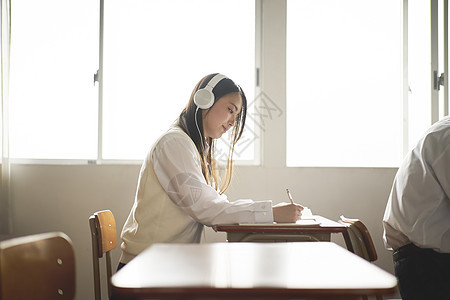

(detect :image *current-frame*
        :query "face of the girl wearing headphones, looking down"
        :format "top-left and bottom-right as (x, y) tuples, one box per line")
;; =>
(202, 93), (242, 139)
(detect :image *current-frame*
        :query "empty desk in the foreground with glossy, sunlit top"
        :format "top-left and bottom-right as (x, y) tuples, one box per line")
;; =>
(112, 242), (397, 299)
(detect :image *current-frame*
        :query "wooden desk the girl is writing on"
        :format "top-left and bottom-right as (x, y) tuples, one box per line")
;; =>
(213, 215), (346, 242)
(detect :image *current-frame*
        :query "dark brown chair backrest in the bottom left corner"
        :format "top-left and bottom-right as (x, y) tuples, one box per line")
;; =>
(0, 232), (75, 300)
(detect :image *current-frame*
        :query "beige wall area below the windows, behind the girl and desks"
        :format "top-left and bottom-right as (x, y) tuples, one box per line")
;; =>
(8, 165), (396, 300)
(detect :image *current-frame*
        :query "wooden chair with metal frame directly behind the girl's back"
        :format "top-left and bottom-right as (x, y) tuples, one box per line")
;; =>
(89, 210), (117, 300)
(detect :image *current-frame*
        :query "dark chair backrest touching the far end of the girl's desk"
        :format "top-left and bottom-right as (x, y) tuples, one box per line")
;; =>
(338, 216), (378, 261)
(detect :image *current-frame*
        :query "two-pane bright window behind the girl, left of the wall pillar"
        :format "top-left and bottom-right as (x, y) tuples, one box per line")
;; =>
(10, 0), (255, 160)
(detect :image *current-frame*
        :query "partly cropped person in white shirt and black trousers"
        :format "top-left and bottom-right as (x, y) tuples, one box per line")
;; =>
(383, 117), (450, 300)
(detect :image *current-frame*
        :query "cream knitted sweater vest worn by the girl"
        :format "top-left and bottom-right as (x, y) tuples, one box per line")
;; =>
(120, 128), (203, 263)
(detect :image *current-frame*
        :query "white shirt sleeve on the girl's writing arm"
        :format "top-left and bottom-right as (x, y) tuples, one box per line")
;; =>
(151, 133), (273, 226)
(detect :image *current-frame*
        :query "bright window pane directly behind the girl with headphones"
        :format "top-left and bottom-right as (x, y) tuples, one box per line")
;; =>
(103, 0), (255, 159)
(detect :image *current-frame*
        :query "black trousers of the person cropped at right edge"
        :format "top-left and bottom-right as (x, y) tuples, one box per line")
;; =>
(394, 244), (450, 300)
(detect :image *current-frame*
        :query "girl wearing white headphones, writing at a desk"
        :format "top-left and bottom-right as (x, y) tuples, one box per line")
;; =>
(119, 74), (303, 269)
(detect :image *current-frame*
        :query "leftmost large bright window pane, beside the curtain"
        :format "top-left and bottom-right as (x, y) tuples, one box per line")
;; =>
(10, 0), (99, 159)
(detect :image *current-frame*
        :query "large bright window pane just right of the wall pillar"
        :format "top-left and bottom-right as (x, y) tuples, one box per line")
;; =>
(287, 0), (402, 167)
